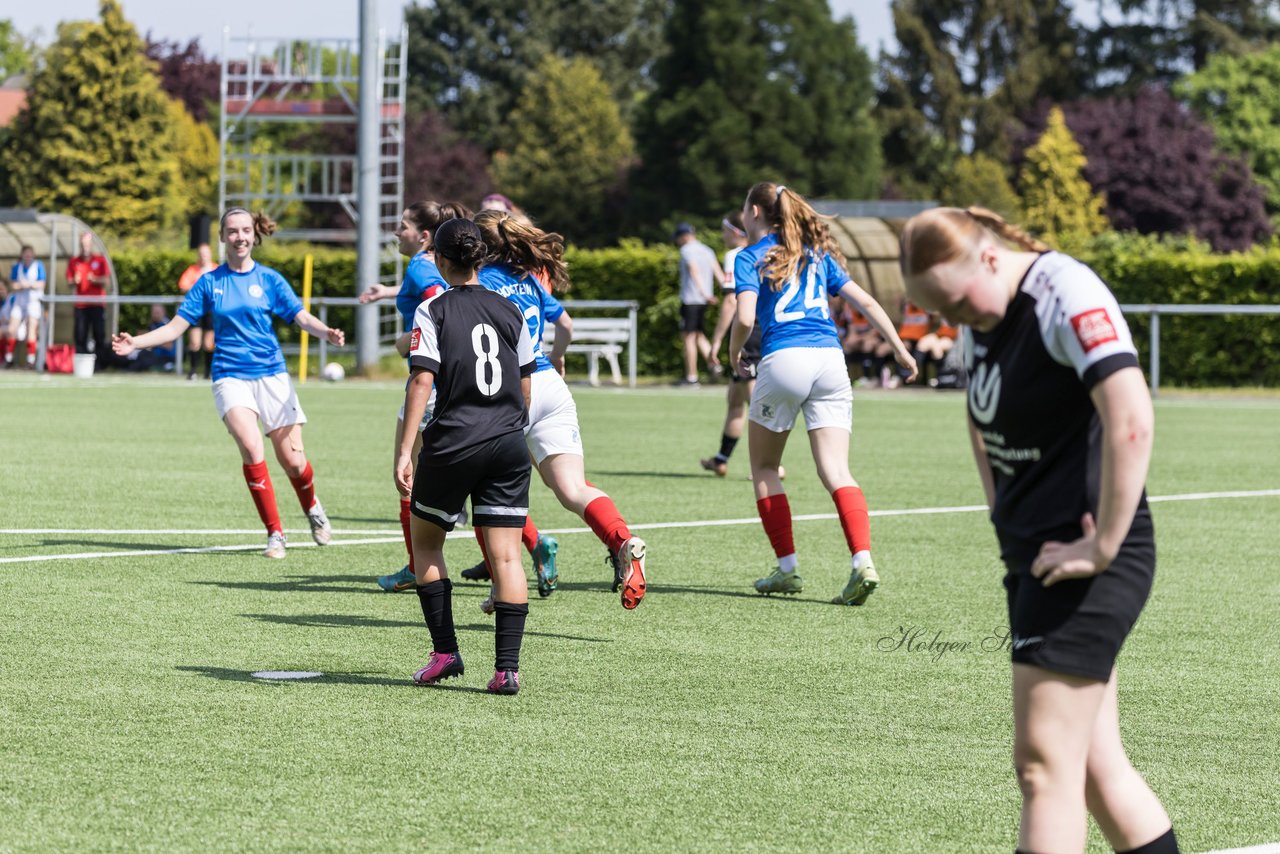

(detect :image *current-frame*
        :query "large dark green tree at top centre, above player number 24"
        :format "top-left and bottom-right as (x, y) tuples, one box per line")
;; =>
(632, 0), (879, 224)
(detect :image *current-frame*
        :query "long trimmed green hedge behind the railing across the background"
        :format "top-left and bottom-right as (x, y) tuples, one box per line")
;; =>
(113, 236), (1280, 387)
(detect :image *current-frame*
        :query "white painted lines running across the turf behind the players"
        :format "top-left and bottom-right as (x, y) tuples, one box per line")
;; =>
(0, 489), (1280, 565)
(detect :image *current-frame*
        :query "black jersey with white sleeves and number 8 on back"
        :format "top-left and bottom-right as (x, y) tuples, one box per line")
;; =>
(408, 287), (535, 463)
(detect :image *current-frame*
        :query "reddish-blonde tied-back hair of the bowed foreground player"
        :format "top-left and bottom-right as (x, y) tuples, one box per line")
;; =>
(899, 207), (1050, 277)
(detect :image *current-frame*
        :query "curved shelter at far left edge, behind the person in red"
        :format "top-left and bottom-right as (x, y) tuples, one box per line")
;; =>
(0, 207), (120, 353)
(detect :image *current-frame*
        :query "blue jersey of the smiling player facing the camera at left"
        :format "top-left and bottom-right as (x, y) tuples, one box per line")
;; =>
(178, 264), (302, 382)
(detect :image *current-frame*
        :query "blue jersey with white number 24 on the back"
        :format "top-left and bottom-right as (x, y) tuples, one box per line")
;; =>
(733, 234), (849, 356)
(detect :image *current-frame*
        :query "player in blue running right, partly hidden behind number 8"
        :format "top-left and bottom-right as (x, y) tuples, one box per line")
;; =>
(475, 210), (646, 609)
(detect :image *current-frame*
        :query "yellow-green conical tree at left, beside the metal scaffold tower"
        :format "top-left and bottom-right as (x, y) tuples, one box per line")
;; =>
(4, 0), (183, 234)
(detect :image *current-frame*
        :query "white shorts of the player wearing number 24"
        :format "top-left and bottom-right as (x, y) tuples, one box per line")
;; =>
(750, 347), (854, 433)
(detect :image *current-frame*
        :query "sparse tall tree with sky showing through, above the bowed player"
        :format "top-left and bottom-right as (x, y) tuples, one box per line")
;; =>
(876, 0), (1083, 195)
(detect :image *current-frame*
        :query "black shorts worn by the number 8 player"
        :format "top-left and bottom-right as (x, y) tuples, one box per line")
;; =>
(410, 430), (530, 531)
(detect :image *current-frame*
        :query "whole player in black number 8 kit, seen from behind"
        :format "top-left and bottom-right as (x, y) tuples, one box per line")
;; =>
(394, 219), (535, 694)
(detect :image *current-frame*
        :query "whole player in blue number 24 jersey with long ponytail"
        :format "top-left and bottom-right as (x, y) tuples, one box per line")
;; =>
(728, 183), (916, 604)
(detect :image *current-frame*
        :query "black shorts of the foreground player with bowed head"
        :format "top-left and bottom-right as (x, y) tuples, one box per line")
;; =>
(1005, 510), (1156, 681)
